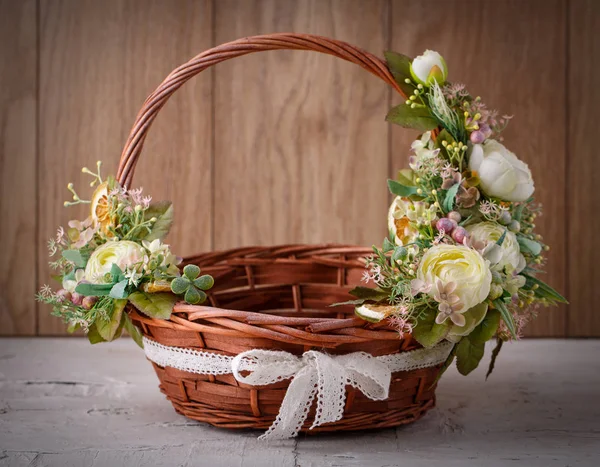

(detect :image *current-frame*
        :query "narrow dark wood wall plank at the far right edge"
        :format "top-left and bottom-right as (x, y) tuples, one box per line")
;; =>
(567, 0), (600, 336)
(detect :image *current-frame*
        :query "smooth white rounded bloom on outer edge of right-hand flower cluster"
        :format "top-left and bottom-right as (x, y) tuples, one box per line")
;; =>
(469, 139), (535, 201)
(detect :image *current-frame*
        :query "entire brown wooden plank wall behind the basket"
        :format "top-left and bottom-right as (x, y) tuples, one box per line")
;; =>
(0, 0), (600, 337)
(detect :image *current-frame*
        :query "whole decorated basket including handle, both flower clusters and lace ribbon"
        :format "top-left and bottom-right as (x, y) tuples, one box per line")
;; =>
(37, 34), (565, 438)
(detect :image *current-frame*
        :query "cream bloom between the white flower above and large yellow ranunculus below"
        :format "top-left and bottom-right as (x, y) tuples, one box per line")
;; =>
(467, 222), (525, 274)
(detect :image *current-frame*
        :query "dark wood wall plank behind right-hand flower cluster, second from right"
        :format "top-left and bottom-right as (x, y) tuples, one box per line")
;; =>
(392, 0), (568, 336)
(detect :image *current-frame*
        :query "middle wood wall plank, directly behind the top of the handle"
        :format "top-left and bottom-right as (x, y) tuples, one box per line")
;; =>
(215, 0), (389, 248)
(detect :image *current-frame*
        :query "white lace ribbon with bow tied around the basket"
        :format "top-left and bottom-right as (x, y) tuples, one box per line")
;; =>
(144, 337), (453, 439)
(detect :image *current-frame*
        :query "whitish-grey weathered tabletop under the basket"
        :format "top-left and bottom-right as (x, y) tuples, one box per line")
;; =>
(0, 338), (600, 467)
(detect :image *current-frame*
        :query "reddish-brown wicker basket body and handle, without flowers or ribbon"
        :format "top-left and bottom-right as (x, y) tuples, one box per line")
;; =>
(118, 34), (440, 431)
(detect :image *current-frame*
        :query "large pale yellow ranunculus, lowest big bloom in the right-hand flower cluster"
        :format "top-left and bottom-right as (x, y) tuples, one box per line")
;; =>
(417, 244), (492, 313)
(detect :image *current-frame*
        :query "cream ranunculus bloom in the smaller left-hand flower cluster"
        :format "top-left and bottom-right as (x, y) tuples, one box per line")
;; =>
(85, 240), (144, 284)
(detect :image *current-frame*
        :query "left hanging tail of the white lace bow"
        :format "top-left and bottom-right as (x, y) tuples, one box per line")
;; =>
(258, 366), (317, 440)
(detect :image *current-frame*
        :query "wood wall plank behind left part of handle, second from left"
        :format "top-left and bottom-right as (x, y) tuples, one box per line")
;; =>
(38, 0), (211, 334)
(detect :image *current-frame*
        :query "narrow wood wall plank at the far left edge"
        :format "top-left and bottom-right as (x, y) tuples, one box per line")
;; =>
(0, 0), (37, 335)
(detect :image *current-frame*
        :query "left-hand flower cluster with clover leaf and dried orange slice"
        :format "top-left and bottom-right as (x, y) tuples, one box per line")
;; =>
(37, 162), (214, 346)
